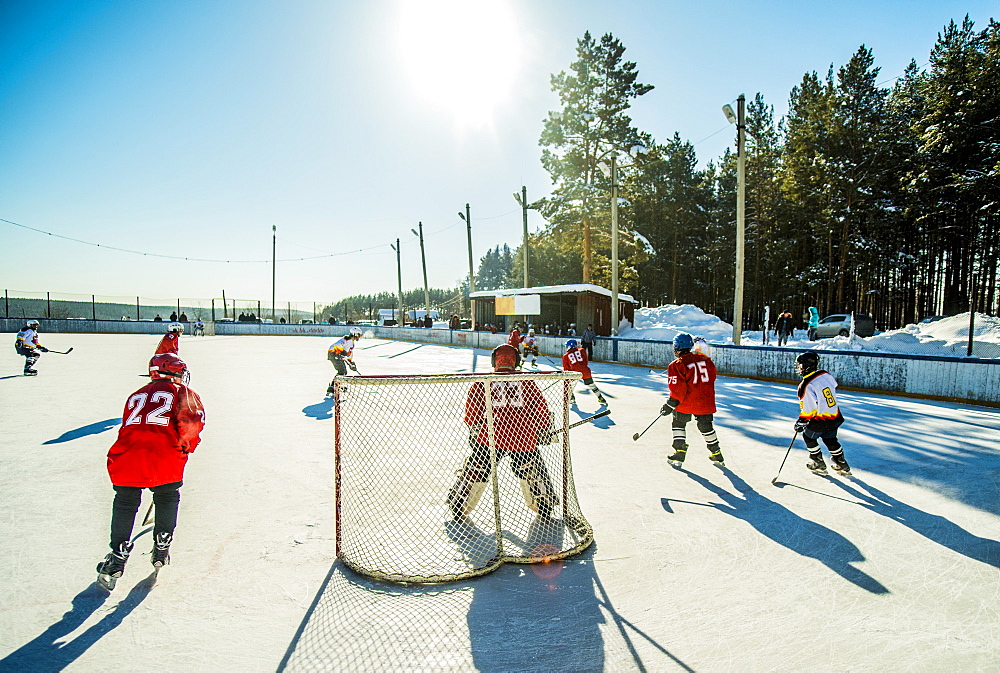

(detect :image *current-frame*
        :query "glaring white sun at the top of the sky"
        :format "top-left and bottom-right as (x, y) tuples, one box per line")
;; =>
(399, 0), (521, 126)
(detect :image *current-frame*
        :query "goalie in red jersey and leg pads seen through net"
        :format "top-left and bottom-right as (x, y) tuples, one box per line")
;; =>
(448, 344), (559, 522)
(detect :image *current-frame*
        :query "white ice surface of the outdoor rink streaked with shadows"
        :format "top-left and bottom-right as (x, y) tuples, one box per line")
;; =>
(0, 332), (1000, 673)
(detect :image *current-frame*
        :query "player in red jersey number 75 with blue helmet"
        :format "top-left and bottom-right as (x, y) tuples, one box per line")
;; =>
(660, 332), (725, 467)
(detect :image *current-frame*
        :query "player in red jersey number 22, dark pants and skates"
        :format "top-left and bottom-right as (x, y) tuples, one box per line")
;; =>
(97, 353), (205, 589)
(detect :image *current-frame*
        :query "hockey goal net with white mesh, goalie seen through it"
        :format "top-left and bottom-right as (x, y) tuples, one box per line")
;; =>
(334, 372), (593, 582)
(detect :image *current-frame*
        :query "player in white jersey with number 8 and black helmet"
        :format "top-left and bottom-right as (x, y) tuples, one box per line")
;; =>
(795, 351), (851, 475)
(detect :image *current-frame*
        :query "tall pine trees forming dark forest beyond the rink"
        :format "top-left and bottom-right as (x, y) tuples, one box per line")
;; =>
(332, 17), (1000, 329)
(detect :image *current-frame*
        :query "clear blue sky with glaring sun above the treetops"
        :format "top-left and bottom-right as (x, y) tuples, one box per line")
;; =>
(0, 0), (996, 303)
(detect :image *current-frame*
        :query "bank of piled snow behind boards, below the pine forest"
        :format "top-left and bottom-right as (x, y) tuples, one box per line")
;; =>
(619, 304), (1000, 356)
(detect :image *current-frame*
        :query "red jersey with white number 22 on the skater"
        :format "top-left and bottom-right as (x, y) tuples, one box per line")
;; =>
(108, 379), (205, 488)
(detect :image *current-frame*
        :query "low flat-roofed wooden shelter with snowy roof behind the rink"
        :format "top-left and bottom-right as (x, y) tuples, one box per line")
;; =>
(471, 283), (638, 336)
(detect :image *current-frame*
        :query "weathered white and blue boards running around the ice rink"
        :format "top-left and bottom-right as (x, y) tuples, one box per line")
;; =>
(0, 318), (1000, 407)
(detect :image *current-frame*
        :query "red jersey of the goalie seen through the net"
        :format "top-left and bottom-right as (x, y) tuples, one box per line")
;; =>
(465, 372), (552, 452)
